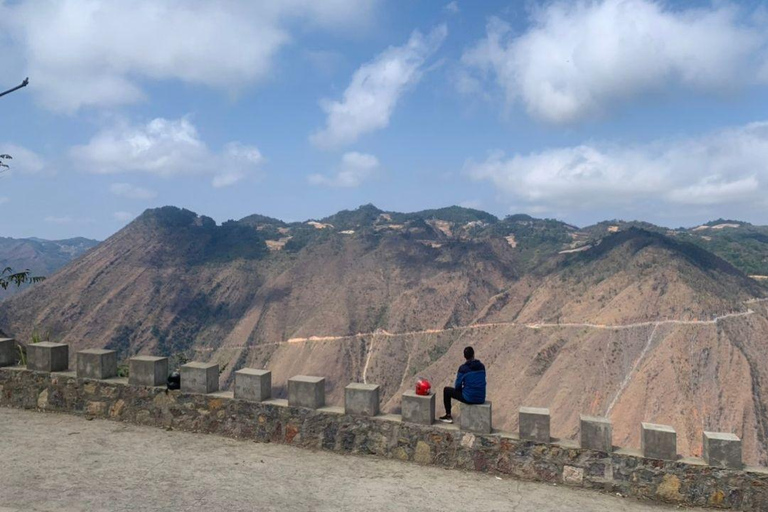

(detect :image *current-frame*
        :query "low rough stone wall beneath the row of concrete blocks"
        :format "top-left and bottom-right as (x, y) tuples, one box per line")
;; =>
(0, 367), (768, 510)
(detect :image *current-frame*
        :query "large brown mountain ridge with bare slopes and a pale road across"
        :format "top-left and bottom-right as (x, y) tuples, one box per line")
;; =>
(0, 205), (768, 463)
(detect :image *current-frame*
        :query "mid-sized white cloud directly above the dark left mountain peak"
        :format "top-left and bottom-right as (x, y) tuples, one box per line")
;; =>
(70, 118), (263, 187)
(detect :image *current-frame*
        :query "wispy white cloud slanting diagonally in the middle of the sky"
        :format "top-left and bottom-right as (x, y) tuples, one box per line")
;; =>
(310, 25), (448, 148)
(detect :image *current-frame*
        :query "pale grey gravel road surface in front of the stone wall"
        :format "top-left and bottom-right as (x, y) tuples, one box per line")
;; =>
(0, 409), (696, 512)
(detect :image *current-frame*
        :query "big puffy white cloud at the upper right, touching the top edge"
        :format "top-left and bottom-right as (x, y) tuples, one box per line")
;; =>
(459, 0), (768, 123)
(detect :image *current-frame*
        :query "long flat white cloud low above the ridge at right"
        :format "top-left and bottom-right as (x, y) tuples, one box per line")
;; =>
(465, 121), (768, 215)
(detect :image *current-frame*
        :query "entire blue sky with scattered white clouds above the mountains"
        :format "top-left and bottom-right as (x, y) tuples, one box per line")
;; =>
(0, 0), (768, 239)
